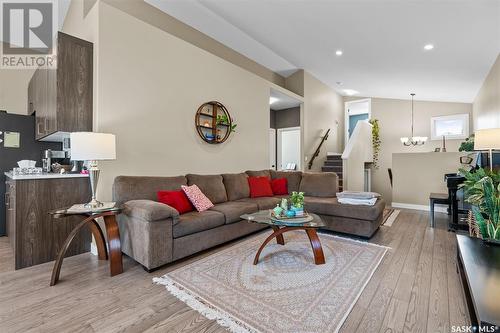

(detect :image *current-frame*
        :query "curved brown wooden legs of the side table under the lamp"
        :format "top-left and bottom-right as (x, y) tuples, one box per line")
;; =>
(50, 213), (123, 286)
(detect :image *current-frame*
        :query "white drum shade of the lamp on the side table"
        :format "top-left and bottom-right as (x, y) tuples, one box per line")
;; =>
(70, 132), (116, 161)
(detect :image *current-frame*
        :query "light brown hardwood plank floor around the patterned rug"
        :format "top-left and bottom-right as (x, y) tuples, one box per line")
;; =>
(0, 210), (469, 333)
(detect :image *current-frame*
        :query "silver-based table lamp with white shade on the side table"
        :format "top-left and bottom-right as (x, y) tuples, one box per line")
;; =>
(70, 132), (116, 208)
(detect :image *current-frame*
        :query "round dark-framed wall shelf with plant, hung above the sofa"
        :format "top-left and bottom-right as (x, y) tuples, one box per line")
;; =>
(194, 101), (233, 144)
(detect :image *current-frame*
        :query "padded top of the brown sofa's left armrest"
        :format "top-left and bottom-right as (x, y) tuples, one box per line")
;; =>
(123, 200), (179, 224)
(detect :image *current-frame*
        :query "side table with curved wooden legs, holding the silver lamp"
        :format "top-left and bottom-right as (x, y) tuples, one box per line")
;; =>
(50, 207), (123, 286)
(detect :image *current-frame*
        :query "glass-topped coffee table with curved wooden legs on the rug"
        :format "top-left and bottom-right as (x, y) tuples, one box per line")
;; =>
(240, 210), (325, 265)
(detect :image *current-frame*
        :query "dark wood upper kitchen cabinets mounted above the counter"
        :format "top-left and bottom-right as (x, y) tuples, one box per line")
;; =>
(28, 32), (94, 141)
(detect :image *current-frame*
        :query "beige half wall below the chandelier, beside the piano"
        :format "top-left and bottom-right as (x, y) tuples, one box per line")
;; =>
(392, 152), (464, 206)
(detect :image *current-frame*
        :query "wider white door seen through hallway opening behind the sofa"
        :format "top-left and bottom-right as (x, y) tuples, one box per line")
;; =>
(277, 127), (301, 170)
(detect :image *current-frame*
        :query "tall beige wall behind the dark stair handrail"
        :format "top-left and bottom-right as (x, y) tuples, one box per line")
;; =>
(299, 72), (344, 171)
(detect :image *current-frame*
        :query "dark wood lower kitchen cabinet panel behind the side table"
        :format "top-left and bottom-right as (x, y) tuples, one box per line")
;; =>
(5, 177), (91, 269)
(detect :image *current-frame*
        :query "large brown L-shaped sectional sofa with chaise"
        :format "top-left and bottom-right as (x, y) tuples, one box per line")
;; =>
(113, 170), (385, 270)
